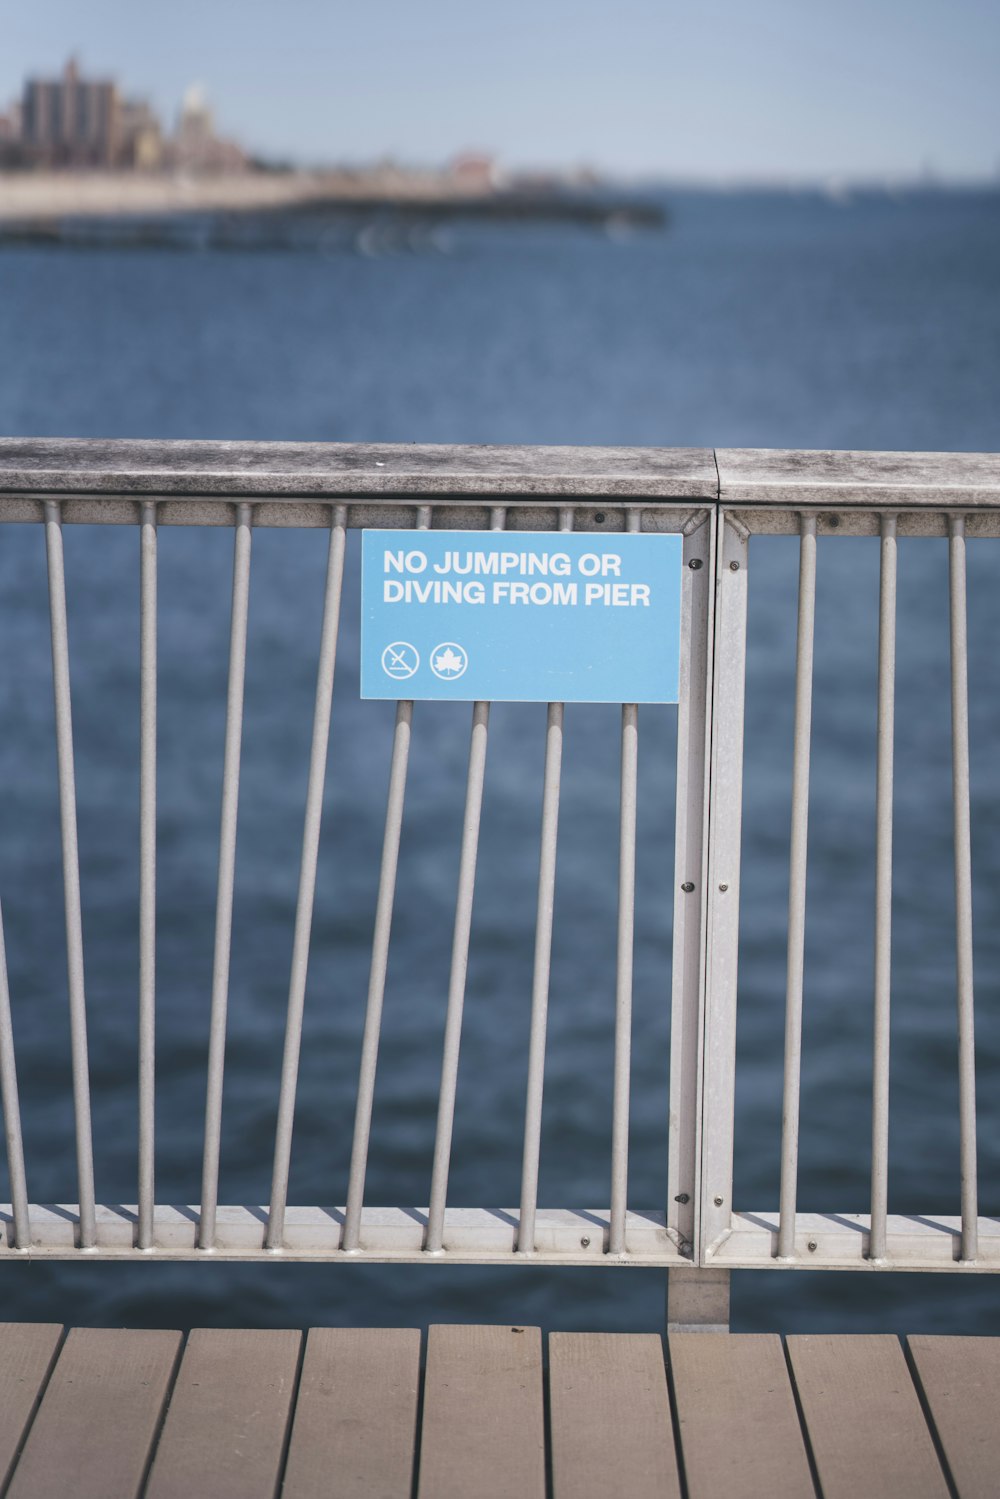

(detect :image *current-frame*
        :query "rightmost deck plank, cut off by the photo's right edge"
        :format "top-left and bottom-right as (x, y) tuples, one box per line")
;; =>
(907, 1337), (1000, 1499)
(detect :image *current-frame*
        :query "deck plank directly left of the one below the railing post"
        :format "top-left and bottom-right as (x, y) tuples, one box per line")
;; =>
(549, 1333), (681, 1499)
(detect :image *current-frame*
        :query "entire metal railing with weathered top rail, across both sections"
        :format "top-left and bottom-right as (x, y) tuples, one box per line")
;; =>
(0, 439), (1000, 1301)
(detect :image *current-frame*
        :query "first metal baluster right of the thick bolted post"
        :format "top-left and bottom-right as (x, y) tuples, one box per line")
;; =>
(778, 514), (816, 1259)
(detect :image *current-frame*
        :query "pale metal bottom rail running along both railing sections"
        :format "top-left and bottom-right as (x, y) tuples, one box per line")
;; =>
(0, 1204), (1000, 1273)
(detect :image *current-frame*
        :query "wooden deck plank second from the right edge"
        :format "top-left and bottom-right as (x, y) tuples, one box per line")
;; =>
(787, 1333), (948, 1499)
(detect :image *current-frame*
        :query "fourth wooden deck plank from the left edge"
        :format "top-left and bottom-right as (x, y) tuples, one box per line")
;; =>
(282, 1327), (420, 1499)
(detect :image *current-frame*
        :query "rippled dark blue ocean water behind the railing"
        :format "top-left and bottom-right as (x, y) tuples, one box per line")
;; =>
(0, 192), (1000, 1331)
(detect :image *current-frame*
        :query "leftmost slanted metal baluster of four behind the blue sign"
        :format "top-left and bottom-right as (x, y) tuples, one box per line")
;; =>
(340, 505), (430, 1253)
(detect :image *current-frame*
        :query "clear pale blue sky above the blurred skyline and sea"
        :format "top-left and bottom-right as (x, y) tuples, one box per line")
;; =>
(0, 0), (1000, 178)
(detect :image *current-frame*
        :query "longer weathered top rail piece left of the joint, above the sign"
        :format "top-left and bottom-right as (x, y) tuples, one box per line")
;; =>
(0, 438), (718, 502)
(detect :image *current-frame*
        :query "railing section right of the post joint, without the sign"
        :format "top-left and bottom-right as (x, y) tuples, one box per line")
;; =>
(699, 451), (1000, 1271)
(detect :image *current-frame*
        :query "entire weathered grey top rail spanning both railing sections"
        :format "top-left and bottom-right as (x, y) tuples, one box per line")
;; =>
(0, 438), (1000, 510)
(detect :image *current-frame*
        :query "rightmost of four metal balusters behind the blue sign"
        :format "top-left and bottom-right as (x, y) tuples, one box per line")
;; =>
(607, 510), (640, 1255)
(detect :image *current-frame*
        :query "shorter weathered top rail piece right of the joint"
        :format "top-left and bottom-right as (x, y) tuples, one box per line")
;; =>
(715, 448), (1000, 510)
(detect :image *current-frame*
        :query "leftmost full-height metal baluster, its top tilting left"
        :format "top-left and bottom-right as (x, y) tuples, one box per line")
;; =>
(45, 499), (97, 1249)
